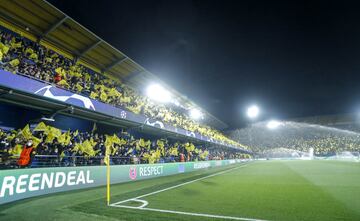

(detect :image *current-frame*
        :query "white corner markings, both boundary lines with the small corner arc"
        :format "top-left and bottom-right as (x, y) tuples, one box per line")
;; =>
(110, 164), (268, 221)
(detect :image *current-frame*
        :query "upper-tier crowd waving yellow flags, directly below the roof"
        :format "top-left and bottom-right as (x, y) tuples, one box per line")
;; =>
(0, 30), (240, 146)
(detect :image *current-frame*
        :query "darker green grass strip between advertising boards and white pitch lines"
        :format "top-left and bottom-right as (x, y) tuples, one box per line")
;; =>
(0, 162), (242, 221)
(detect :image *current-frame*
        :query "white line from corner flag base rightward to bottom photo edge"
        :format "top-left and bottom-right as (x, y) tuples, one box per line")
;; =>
(113, 205), (268, 221)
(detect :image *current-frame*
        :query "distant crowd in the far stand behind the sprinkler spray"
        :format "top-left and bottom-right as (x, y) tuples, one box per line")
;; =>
(231, 122), (360, 156)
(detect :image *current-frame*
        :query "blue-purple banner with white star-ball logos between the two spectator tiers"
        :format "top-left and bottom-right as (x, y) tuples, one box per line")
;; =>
(0, 70), (230, 146)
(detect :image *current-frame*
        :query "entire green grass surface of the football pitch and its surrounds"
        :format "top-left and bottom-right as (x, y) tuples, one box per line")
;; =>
(0, 161), (360, 221)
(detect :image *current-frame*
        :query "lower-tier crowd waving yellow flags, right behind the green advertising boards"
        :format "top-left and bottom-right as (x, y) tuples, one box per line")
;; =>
(0, 122), (249, 167)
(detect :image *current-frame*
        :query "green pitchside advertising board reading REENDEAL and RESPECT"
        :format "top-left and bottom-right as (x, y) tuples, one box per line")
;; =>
(0, 160), (242, 204)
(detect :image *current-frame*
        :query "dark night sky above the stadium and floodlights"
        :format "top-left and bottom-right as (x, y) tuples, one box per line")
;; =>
(49, 0), (360, 128)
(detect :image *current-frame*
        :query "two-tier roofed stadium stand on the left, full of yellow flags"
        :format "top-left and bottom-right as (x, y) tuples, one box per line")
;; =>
(0, 1), (250, 169)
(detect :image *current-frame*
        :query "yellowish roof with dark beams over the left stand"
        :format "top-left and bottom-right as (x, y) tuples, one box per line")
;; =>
(0, 0), (227, 129)
